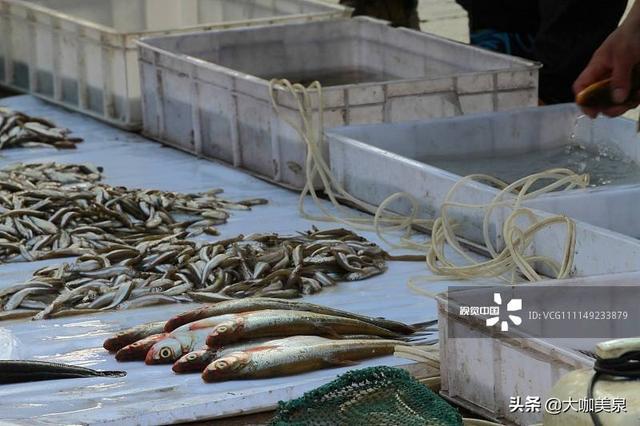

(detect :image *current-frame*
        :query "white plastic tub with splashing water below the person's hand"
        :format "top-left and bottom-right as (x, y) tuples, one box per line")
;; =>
(326, 104), (640, 240)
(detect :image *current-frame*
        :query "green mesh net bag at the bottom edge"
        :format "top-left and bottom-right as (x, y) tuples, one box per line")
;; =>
(271, 367), (463, 426)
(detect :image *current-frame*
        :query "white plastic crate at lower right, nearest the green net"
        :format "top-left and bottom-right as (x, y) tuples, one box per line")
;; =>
(437, 272), (640, 425)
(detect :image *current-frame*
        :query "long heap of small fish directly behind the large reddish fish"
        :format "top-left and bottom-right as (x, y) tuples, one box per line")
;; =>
(0, 228), (390, 320)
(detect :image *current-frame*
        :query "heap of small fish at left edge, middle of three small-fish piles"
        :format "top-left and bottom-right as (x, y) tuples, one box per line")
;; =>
(0, 163), (267, 261)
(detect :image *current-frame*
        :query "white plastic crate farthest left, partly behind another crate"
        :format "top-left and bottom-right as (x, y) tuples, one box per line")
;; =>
(0, 0), (349, 130)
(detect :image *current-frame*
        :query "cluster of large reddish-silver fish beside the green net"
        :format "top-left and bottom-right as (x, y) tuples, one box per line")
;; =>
(104, 298), (432, 382)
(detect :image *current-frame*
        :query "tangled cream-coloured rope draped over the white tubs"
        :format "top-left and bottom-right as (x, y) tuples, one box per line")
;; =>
(269, 79), (588, 286)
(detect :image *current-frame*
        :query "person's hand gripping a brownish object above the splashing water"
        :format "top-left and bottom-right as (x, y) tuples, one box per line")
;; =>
(573, 0), (640, 118)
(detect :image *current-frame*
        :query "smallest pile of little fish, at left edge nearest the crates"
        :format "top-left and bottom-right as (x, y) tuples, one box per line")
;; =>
(0, 107), (82, 149)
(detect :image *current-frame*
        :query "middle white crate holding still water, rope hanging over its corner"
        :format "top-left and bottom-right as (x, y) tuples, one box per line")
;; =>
(139, 18), (538, 188)
